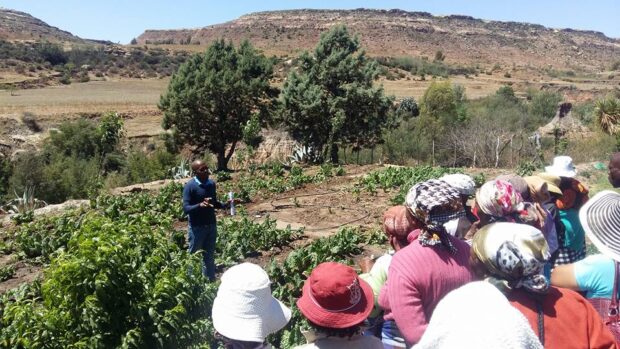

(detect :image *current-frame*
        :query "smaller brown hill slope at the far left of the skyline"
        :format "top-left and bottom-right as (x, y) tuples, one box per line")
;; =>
(0, 8), (84, 43)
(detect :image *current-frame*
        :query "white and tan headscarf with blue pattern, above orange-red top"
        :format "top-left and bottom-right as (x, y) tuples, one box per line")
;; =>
(472, 222), (550, 293)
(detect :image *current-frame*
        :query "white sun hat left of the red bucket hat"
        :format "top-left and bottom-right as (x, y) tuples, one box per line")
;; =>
(212, 263), (291, 342)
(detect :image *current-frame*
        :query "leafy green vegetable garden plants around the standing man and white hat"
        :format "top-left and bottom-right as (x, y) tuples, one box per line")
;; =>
(0, 167), (464, 348)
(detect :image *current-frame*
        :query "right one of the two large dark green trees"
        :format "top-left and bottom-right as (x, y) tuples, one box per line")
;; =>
(281, 26), (392, 163)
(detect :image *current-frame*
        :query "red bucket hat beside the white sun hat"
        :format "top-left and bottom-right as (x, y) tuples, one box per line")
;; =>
(297, 262), (374, 328)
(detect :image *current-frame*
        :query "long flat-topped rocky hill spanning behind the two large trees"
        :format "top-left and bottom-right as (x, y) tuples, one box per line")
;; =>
(137, 9), (620, 71)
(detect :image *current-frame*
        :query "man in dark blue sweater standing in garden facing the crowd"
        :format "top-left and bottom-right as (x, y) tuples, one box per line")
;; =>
(183, 160), (225, 282)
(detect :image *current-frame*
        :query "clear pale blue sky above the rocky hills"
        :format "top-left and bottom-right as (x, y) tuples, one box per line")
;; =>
(0, 0), (620, 44)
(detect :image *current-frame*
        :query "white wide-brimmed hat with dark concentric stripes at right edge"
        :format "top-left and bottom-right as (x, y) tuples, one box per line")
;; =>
(579, 190), (620, 262)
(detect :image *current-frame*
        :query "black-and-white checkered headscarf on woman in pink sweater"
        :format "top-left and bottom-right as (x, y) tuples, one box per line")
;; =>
(405, 179), (465, 253)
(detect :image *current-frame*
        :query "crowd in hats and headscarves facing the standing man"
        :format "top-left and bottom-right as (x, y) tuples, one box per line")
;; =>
(187, 153), (620, 349)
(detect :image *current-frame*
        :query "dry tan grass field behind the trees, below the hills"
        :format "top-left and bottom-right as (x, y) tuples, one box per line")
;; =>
(0, 71), (617, 143)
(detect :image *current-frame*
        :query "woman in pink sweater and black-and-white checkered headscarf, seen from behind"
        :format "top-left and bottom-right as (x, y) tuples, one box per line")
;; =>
(379, 180), (472, 346)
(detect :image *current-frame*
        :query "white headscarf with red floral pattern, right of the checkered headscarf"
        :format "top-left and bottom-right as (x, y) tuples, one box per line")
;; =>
(476, 180), (523, 217)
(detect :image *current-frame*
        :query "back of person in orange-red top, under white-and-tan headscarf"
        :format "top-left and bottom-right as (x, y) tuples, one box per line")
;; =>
(508, 287), (617, 349)
